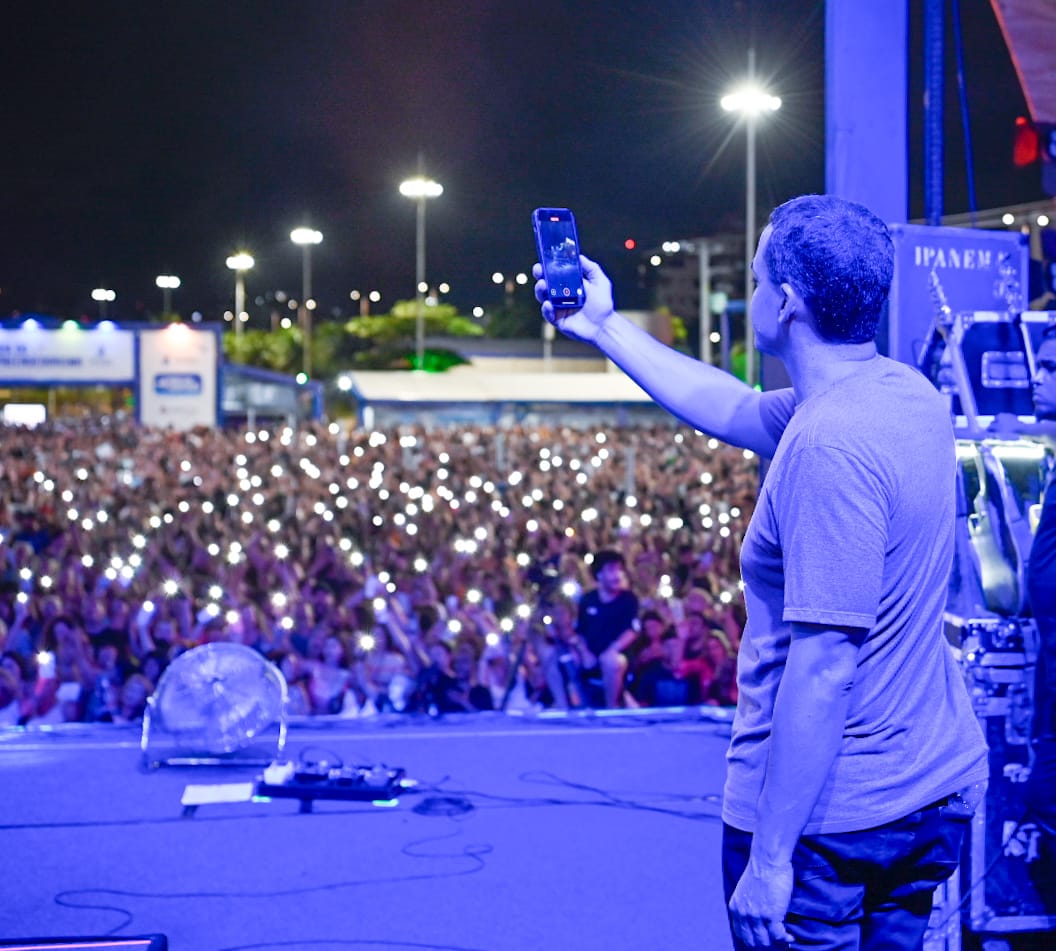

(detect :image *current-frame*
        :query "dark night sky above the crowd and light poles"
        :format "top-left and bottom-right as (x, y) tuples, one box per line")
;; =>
(0, 0), (1042, 320)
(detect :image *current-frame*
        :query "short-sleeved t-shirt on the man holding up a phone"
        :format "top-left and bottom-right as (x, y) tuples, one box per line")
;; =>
(722, 357), (987, 834)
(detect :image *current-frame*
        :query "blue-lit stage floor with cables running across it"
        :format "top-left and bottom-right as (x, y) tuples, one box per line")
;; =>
(0, 709), (731, 951)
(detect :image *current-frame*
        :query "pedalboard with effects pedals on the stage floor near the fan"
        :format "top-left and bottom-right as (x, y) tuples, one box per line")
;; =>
(254, 763), (405, 813)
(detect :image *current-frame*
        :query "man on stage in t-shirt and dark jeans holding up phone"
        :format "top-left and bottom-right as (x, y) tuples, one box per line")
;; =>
(536, 195), (987, 951)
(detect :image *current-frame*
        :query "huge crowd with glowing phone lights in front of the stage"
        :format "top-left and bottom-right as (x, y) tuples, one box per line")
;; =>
(0, 417), (757, 726)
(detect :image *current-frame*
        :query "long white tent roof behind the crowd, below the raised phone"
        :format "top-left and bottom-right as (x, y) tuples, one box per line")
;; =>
(347, 366), (652, 403)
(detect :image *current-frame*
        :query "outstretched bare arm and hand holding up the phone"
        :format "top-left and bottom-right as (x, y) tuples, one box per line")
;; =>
(532, 255), (777, 457)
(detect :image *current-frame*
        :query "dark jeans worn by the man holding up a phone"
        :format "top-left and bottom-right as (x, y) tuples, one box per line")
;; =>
(722, 803), (968, 951)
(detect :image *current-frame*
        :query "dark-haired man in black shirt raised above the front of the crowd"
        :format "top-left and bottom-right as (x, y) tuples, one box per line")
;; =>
(576, 549), (639, 707)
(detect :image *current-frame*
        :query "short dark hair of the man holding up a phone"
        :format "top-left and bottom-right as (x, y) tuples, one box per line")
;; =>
(766, 195), (894, 343)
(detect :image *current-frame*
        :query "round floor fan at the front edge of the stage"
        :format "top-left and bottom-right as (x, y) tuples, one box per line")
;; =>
(140, 643), (286, 767)
